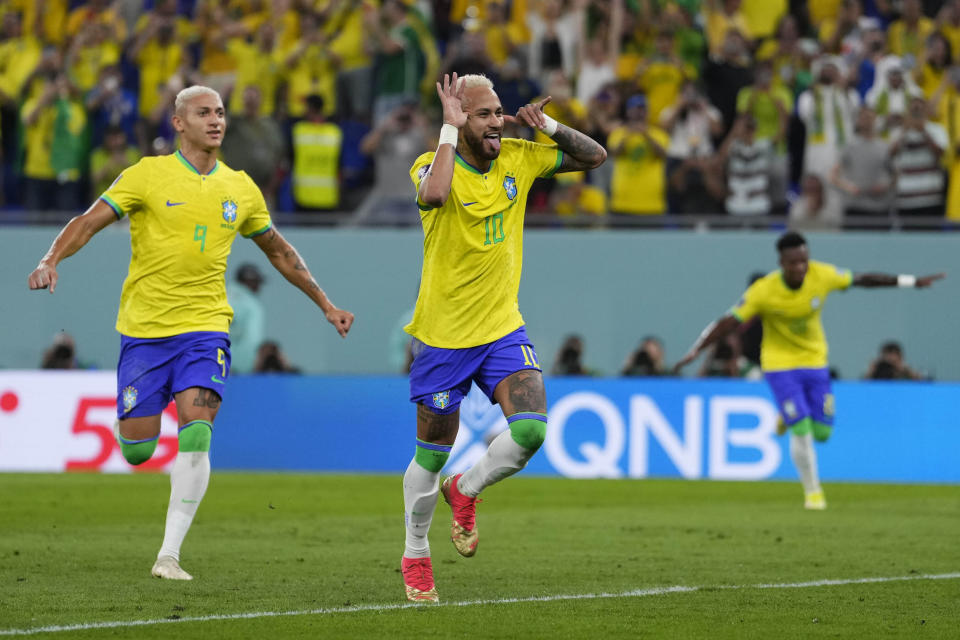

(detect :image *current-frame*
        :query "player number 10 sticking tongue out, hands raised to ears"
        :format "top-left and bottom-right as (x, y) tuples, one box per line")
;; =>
(401, 73), (607, 602)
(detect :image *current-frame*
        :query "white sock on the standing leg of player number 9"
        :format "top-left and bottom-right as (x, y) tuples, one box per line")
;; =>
(157, 451), (210, 562)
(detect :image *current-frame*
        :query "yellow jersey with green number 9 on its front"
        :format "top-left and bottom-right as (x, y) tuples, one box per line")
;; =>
(100, 151), (271, 338)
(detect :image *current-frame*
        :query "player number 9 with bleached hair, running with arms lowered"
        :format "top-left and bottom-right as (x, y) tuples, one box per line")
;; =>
(28, 86), (353, 580)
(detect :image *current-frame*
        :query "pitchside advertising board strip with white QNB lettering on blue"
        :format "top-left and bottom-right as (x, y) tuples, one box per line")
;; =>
(0, 371), (960, 483)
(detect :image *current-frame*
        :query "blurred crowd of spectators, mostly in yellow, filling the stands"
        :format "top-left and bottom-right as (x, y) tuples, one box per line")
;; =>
(0, 0), (960, 228)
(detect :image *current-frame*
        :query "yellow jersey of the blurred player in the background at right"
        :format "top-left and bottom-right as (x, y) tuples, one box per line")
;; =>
(730, 260), (853, 371)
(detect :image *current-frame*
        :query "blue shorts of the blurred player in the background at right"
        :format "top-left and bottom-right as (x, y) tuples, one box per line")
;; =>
(764, 367), (834, 426)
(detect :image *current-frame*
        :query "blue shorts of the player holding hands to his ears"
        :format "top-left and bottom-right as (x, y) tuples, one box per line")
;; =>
(410, 327), (540, 414)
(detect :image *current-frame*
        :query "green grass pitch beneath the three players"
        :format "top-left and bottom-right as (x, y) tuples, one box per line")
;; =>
(0, 472), (960, 640)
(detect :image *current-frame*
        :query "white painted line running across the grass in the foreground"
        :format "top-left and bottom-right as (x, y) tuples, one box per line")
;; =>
(0, 572), (960, 636)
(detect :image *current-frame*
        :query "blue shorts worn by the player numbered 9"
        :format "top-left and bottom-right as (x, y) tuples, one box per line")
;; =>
(117, 331), (230, 419)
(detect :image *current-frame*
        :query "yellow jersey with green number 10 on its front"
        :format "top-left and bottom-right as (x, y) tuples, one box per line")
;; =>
(405, 138), (563, 349)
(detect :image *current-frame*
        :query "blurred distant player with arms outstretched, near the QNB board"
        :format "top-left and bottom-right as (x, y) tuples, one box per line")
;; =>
(674, 231), (944, 510)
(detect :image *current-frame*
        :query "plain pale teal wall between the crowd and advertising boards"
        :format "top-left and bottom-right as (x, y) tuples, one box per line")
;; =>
(0, 226), (960, 380)
